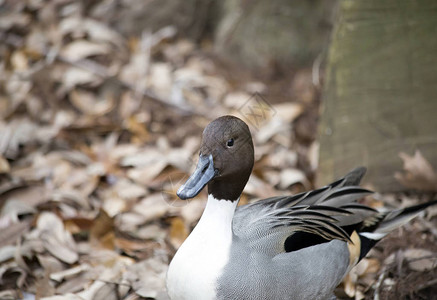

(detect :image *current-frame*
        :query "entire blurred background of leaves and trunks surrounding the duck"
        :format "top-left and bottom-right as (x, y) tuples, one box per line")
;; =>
(0, 0), (437, 300)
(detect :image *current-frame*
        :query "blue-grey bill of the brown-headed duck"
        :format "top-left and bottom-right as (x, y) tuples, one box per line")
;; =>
(176, 154), (215, 200)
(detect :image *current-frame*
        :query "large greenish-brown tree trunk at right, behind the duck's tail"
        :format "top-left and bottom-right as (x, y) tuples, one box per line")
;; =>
(318, 0), (437, 192)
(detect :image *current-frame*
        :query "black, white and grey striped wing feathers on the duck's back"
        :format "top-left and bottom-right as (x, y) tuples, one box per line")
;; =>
(233, 168), (377, 252)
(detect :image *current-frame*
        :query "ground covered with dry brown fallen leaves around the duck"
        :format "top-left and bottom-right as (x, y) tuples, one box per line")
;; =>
(0, 1), (437, 300)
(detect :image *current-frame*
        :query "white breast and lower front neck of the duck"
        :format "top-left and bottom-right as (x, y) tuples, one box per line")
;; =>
(167, 195), (238, 300)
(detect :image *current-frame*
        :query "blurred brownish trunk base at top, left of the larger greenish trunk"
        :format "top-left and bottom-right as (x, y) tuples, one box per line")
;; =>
(214, 0), (336, 73)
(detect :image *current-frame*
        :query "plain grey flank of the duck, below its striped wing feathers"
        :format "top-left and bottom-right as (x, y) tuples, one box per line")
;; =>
(217, 238), (349, 300)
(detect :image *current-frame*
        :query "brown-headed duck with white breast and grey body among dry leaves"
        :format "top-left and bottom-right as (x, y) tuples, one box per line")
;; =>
(167, 116), (436, 300)
